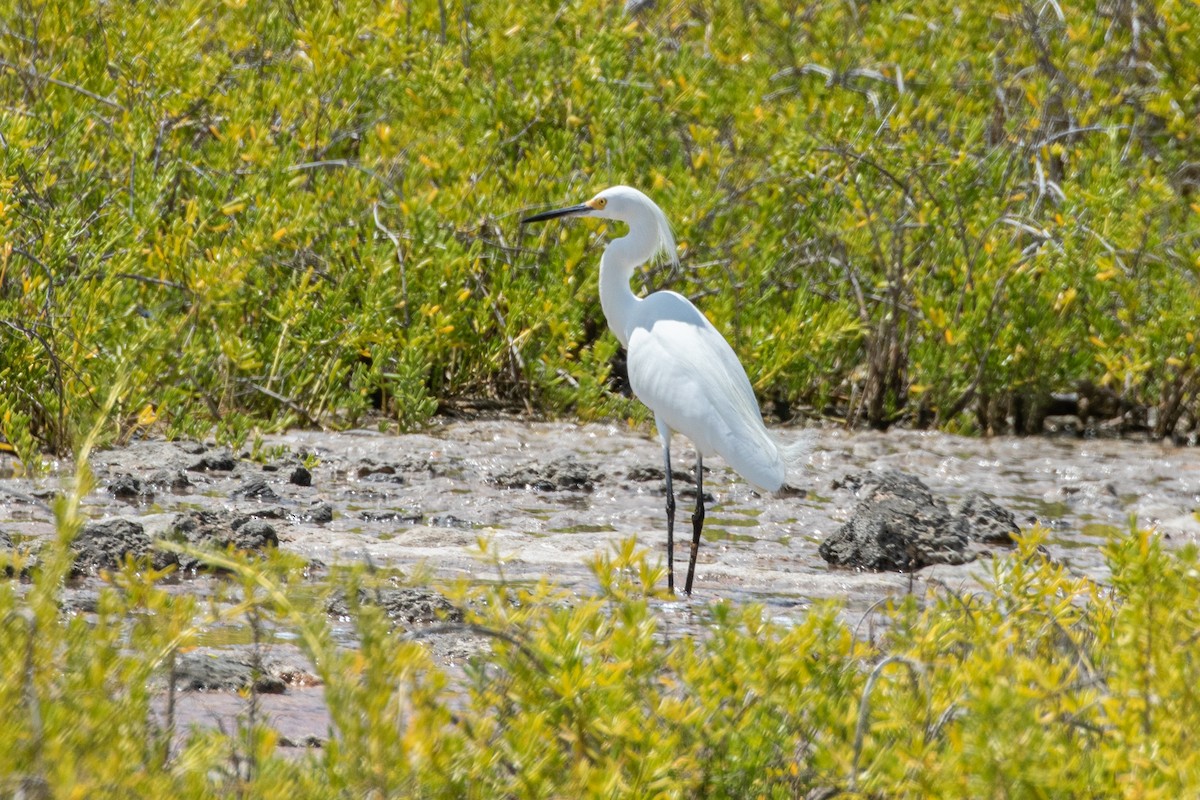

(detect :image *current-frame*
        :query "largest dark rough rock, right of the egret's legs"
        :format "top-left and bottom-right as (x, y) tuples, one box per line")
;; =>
(820, 470), (974, 571)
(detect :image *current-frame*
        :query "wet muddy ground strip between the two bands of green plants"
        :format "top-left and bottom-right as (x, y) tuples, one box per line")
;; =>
(0, 420), (1200, 744)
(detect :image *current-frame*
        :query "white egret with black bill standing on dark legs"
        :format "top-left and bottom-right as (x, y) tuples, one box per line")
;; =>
(521, 186), (805, 595)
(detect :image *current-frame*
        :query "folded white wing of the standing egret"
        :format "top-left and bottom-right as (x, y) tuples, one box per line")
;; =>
(628, 291), (785, 489)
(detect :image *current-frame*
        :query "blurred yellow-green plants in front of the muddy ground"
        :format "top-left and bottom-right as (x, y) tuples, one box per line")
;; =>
(0, 448), (1200, 798)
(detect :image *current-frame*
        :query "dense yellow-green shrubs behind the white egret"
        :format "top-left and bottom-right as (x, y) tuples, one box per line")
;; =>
(0, 0), (1200, 461)
